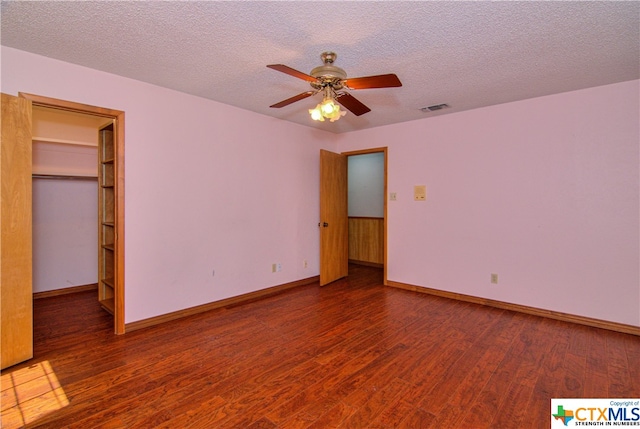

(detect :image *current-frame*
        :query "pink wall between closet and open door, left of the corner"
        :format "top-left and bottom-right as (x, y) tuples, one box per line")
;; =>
(2, 47), (336, 323)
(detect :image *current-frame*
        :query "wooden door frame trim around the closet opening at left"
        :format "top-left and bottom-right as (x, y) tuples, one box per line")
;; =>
(18, 92), (125, 334)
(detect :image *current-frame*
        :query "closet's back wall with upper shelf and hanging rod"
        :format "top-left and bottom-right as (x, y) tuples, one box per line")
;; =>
(32, 106), (110, 297)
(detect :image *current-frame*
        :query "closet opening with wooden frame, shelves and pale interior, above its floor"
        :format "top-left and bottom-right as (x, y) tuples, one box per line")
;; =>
(19, 93), (125, 334)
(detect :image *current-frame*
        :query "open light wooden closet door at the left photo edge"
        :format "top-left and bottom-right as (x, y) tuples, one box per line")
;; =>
(0, 94), (33, 368)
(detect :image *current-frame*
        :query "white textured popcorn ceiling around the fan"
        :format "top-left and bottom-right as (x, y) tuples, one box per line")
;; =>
(1, 1), (640, 133)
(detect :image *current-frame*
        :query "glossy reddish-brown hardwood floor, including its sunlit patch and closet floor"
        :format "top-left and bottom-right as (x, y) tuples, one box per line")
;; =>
(2, 266), (640, 428)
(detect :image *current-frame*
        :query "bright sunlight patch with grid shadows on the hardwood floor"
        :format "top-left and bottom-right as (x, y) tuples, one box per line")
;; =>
(0, 361), (69, 429)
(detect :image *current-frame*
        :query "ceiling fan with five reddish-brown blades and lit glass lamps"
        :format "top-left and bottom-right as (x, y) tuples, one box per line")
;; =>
(267, 52), (402, 122)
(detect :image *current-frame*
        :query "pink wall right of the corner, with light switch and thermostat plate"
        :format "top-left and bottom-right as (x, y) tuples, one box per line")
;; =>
(339, 81), (640, 326)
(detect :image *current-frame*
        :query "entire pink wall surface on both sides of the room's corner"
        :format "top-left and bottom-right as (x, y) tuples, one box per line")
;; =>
(2, 47), (640, 326)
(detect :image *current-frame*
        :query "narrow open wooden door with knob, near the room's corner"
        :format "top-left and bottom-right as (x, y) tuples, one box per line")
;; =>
(319, 150), (349, 286)
